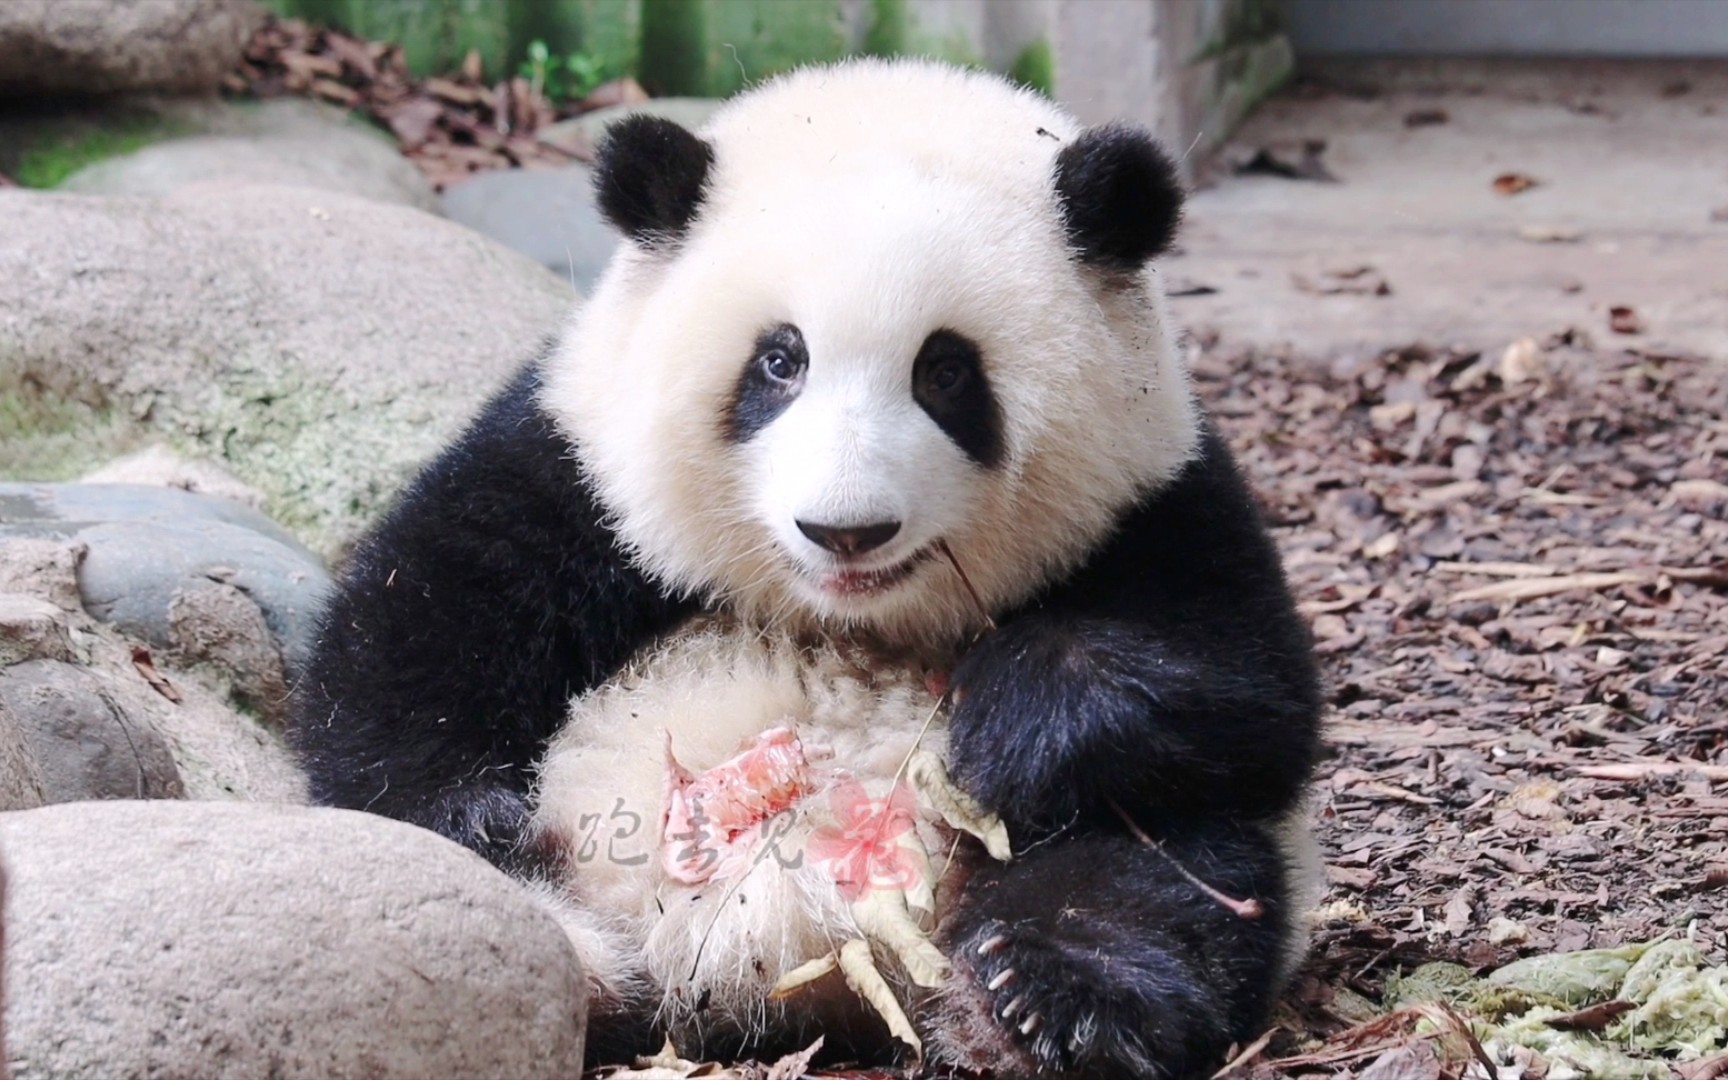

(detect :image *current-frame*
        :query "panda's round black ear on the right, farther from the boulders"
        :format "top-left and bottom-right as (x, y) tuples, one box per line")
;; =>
(1056, 124), (1182, 270)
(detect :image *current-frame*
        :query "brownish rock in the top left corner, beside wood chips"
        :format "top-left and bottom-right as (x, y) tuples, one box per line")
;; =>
(0, 0), (259, 93)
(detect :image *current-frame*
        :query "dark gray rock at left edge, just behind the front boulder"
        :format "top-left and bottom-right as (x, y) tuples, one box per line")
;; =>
(0, 660), (185, 802)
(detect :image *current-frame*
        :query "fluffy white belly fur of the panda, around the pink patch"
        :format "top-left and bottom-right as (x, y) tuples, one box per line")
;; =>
(536, 619), (950, 1030)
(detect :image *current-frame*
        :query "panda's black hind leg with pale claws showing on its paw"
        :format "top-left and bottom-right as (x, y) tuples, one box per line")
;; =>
(930, 823), (1289, 1080)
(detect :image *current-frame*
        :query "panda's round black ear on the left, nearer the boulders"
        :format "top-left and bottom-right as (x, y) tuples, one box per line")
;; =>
(594, 116), (714, 245)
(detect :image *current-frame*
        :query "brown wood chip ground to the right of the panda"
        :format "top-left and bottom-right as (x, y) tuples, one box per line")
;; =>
(1196, 340), (1728, 1077)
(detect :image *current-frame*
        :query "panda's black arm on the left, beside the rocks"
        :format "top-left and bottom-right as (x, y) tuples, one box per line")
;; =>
(290, 365), (683, 864)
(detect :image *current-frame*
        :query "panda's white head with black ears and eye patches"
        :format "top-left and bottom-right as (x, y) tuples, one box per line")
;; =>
(543, 60), (1198, 641)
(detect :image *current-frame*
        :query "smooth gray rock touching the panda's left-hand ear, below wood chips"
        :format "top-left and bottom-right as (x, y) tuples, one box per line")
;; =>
(444, 164), (619, 290)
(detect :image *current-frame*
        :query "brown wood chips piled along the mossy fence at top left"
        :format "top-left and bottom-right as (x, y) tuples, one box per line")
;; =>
(223, 17), (648, 190)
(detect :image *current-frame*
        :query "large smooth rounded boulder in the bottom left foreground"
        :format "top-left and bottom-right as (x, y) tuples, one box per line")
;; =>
(0, 802), (586, 1080)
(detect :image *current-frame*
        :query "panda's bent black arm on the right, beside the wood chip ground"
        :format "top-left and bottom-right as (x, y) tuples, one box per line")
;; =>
(950, 427), (1320, 840)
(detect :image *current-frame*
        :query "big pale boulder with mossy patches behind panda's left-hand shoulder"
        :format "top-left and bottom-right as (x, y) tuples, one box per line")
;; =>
(0, 187), (575, 556)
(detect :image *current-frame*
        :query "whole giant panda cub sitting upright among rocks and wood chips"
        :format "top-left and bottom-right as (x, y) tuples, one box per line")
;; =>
(290, 60), (1320, 1078)
